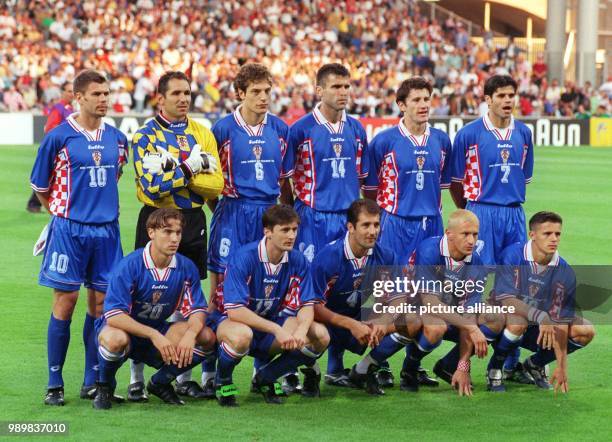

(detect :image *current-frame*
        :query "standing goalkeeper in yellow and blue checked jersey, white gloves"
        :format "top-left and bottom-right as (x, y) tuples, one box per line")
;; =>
(128, 71), (223, 401)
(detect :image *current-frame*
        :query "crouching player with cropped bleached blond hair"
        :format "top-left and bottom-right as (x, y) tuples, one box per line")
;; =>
(416, 209), (504, 396)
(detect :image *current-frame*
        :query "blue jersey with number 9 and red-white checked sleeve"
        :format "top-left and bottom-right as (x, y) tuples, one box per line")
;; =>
(364, 120), (451, 217)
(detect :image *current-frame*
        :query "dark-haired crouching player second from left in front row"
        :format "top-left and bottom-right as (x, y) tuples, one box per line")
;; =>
(211, 205), (329, 406)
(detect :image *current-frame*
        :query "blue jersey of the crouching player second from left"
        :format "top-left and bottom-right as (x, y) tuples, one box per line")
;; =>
(217, 238), (314, 320)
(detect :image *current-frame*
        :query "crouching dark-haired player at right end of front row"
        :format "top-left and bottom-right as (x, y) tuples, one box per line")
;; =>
(491, 212), (595, 393)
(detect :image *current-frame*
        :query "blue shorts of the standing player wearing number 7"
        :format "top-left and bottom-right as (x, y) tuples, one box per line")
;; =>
(466, 201), (527, 265)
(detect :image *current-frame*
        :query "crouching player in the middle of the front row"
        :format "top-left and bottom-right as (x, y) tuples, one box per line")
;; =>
(302, 200), (420, 394)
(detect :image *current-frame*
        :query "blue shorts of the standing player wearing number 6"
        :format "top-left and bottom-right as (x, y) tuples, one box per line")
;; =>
(208, 197), (275, 273)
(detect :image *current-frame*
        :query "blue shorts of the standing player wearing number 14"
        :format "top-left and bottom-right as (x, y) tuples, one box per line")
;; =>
(295, 199), (346, 262)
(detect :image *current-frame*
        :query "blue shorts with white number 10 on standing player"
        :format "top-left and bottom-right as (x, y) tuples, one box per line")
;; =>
(38, 216), (123, 292)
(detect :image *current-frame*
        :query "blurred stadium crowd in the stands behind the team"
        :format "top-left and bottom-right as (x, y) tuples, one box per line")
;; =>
(0, 0), (612, 120)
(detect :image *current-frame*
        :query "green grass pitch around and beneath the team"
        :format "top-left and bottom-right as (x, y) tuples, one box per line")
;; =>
(0, 146), (612, 441)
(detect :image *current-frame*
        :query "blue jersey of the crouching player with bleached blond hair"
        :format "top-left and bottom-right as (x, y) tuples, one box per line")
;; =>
(415, 235), (488, 307)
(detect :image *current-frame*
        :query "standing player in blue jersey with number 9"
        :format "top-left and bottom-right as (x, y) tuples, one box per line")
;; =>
(364, 77), (451, 386)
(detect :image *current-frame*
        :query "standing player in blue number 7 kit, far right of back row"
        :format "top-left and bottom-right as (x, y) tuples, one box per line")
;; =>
(450, 75), (533, 382)
